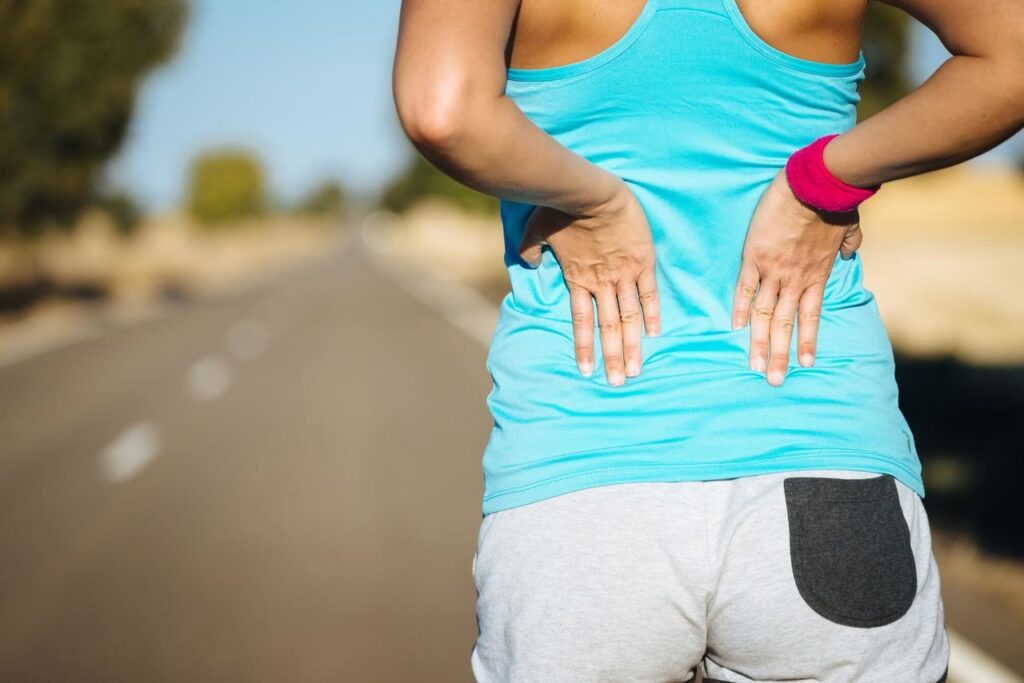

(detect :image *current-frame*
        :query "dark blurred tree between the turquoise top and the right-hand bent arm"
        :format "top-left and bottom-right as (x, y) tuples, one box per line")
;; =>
(857, 2), (911, 120)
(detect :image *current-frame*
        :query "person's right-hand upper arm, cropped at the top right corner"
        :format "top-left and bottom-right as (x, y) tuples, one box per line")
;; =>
(881, 0), (1024, 63)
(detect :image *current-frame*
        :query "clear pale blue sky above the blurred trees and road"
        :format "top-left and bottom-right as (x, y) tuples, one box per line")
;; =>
(108, 0), (1020, 208)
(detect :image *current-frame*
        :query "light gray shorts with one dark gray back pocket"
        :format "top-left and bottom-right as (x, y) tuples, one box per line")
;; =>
(471, 470), (949, 683)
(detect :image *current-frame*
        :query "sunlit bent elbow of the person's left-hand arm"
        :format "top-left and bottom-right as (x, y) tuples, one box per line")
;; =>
(394, 68), (471, 154)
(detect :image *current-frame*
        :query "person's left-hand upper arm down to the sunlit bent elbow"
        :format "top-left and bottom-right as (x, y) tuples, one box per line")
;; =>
(392, 0), (519, 141)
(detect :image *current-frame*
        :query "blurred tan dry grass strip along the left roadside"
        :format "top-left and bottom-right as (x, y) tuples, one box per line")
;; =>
(0, 209), (338, 361)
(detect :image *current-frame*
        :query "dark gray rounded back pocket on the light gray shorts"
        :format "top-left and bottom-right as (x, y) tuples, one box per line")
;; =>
(782, 474), (918, 628)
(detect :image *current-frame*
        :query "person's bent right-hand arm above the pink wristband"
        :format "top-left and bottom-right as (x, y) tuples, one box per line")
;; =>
(824, 0), (1024, 187)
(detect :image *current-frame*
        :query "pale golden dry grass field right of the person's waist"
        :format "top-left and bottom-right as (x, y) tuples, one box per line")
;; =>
(861, 167), (1024, 364)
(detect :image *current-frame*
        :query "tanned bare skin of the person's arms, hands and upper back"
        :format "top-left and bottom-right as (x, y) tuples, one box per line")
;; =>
(392, 0), (1024, 385)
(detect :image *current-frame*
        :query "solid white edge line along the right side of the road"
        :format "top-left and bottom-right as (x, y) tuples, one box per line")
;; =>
(368, 245), (1024, 683)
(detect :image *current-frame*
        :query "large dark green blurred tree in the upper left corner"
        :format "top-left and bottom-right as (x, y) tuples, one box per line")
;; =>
(0, 0), (186, 237)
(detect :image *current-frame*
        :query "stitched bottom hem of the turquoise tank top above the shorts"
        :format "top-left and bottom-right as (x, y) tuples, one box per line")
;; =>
(481, 449), (925, 516)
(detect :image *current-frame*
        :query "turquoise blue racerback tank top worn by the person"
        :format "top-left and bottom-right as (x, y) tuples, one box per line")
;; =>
(482, 0), (925, 515)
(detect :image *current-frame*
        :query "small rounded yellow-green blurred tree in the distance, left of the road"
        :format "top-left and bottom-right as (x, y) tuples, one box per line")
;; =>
(188, 150), (266, 225)
